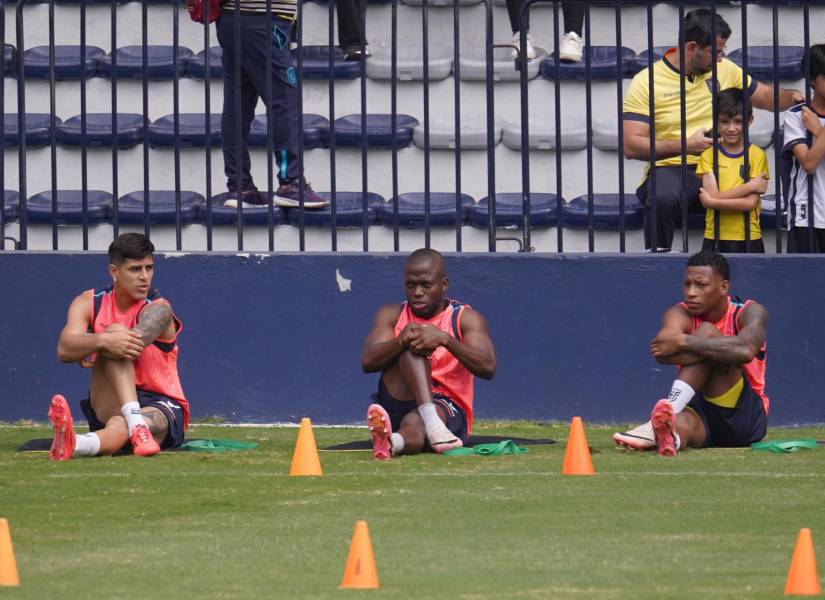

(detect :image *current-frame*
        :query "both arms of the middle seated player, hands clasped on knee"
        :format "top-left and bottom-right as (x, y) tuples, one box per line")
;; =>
(361, 304), (496, 379)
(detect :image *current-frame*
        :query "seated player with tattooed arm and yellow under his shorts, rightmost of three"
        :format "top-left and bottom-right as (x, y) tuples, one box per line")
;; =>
(613, 250), (769, 456)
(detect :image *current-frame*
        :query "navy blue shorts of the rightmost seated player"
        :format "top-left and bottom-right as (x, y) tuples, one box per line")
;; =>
(687, 377), (768, 448)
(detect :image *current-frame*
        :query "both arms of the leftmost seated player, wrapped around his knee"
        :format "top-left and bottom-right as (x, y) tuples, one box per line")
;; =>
(57, 291), (175, 367)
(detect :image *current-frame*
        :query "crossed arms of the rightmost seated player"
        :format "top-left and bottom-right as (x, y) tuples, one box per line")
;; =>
(650, 302), (768, 366)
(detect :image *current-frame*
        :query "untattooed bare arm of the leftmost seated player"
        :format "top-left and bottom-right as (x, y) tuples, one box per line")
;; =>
(57, 292), (143, 363)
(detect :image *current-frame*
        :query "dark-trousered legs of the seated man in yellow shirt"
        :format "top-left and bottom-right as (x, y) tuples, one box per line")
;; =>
(636, 167), (701, 251)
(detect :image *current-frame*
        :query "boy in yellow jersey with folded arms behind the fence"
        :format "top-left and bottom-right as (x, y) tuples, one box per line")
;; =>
(696, 88), (768, 253)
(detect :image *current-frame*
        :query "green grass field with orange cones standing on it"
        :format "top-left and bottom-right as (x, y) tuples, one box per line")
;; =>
(0, 423), (825, 600)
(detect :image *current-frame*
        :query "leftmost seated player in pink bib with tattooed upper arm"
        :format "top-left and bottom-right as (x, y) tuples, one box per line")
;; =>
(49, 233), (189, 460)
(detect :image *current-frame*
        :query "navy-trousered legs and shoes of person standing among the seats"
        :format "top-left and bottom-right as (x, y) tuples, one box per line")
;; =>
(216, 0), (329, 208)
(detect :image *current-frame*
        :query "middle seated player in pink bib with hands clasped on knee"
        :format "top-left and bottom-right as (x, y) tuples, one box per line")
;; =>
(361, 249), (496, 460)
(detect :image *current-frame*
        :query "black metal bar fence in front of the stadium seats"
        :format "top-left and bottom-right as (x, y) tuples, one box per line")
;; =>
(0, 0), (825, 252)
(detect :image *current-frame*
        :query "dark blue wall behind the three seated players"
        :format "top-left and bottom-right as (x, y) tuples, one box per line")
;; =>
(0, 252), (825, 425)
